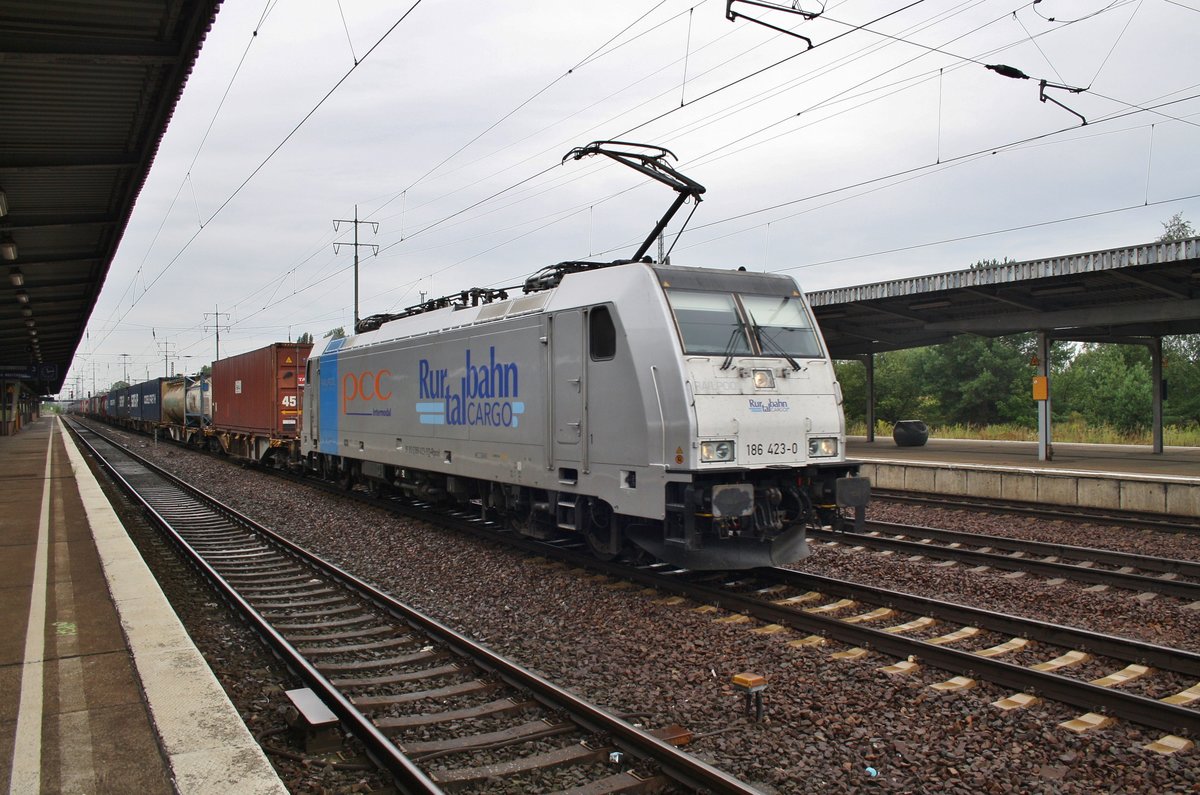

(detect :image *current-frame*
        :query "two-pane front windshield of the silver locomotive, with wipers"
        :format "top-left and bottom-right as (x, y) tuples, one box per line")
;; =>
(666, 289), (823, 359)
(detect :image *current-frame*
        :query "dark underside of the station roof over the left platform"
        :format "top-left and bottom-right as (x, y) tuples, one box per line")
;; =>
(0, 0), (221, 395)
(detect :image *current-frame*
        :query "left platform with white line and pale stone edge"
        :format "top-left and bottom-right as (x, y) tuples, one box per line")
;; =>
(0, 417), (287, 794)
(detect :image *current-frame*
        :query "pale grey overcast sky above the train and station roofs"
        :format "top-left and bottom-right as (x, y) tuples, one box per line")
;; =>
(65, 0), (1200, 393)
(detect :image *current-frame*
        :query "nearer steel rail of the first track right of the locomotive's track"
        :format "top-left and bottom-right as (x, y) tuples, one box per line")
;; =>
(809, 530), (1200, 602)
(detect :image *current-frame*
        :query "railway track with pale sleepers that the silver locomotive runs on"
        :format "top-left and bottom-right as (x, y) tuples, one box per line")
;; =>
(72, 417), (1200, 752)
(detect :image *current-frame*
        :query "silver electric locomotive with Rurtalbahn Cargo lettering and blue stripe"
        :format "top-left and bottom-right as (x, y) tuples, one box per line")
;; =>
(301, 262), (869, 568)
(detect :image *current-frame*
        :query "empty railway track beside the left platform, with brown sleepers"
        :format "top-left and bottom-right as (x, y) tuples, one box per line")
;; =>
(73, 425), (756, 794)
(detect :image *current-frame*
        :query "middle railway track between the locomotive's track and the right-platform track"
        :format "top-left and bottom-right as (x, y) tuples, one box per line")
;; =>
(809, 521), (1200, 602)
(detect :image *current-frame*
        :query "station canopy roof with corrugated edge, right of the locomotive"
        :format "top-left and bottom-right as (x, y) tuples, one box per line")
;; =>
(809, 238), (1200, 359)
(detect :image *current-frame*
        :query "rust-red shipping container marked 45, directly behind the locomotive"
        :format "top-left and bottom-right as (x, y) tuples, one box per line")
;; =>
(212, 342), (312, 438)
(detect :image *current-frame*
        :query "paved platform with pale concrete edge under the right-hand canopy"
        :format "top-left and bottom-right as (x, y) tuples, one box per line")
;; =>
(846, 436), (1200, 519)
